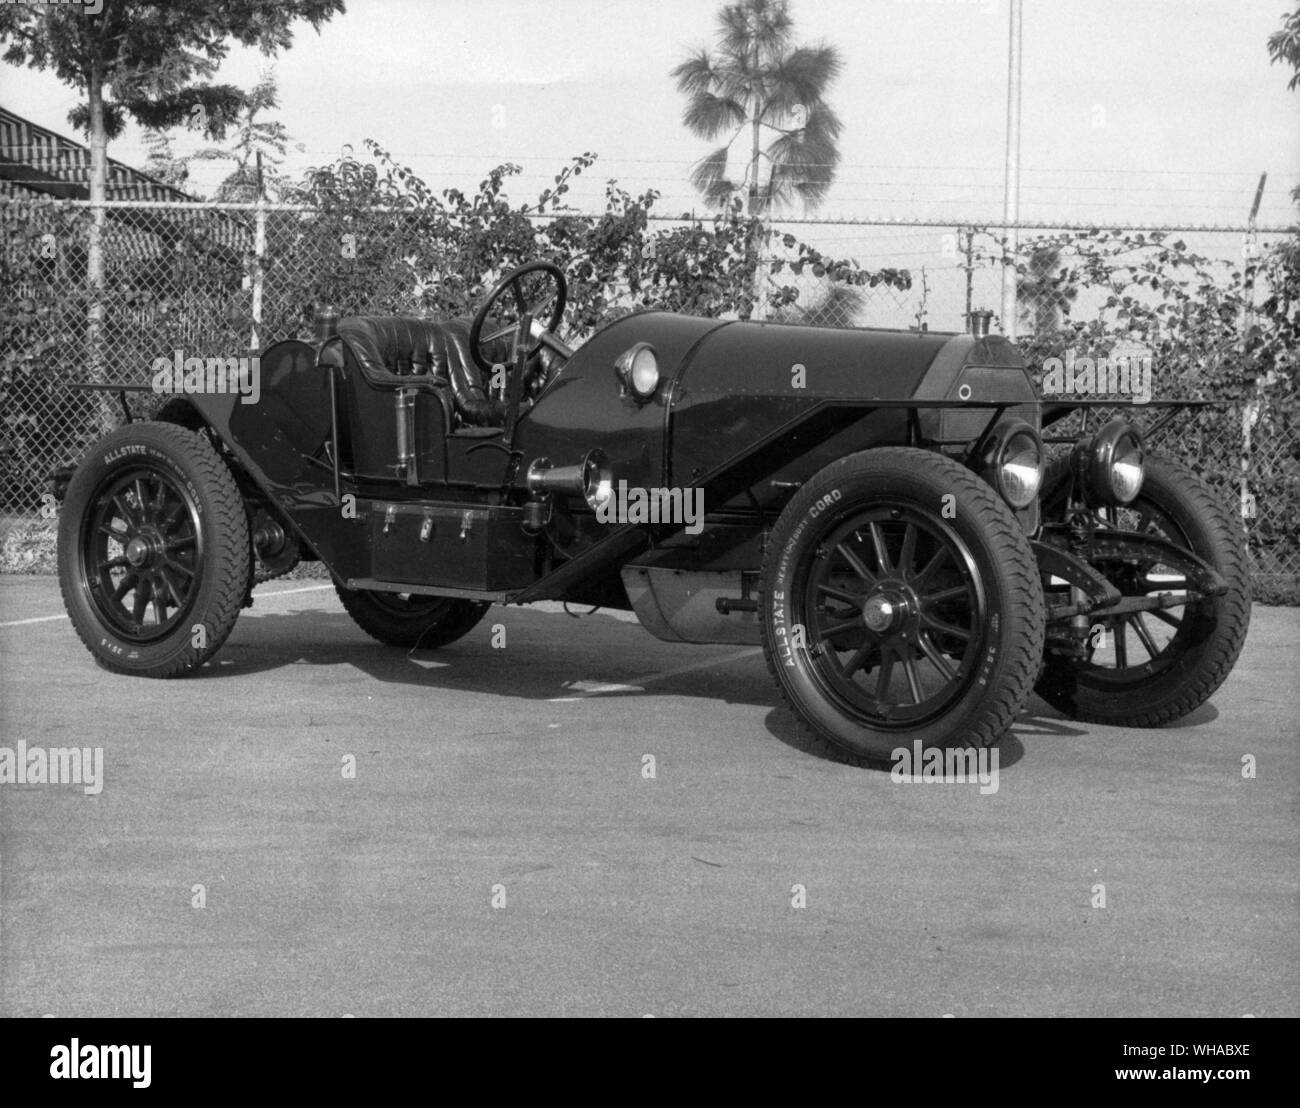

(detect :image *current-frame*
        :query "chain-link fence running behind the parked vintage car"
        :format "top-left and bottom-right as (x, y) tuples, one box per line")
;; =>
(0, 196), (1300, 602)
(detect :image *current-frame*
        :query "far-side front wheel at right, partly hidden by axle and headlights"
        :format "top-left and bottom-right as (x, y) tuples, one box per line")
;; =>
(1036, 456), (1251, 727)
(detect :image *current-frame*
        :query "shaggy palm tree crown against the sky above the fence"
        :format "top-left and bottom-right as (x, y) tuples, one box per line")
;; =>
(672, 0), (844, 216)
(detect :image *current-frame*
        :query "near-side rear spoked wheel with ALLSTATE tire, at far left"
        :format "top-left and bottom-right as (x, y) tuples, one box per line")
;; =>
(59, 423), (251, 678)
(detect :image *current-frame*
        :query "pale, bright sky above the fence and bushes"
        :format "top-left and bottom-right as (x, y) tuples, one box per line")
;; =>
(0, 0), (1300, 224)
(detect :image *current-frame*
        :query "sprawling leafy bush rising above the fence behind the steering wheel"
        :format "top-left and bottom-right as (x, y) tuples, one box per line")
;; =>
(267, 142), (911, 338)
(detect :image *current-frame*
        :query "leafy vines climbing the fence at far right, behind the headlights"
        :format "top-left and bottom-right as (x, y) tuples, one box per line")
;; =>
(980, 228), (1300, 587)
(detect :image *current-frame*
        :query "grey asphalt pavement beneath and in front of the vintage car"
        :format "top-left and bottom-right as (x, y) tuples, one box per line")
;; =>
(0, 577), (1300, 1018)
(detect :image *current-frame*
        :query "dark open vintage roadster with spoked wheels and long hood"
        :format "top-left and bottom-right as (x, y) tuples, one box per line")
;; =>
(59, 261), (1249, 763)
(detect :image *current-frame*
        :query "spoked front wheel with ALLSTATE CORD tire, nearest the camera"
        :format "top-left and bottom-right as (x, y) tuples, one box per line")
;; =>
(759, 447), (1044, 765)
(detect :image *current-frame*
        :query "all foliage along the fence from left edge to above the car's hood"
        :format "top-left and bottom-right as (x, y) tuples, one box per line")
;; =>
(0, 143), (910, 511)
